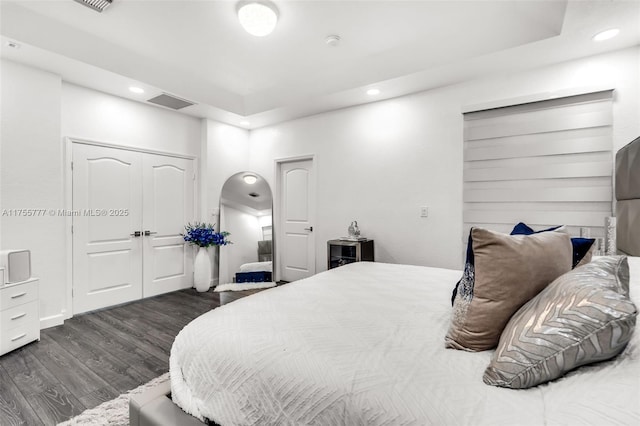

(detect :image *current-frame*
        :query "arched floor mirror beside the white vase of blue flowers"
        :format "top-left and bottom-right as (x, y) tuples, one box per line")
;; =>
(219, 172), (273, 284)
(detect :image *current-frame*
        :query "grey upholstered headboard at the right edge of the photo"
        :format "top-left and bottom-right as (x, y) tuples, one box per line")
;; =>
(616, 137), (640, 256)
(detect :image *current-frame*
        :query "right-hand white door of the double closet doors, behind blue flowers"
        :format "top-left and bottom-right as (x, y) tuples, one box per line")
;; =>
(142, 154), (194, 297)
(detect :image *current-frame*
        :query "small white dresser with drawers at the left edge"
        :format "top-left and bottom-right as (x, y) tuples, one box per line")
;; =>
(0, 278), (40, 355)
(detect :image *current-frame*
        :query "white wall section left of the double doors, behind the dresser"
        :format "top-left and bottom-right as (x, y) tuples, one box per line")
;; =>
(0, 60), (67, 326)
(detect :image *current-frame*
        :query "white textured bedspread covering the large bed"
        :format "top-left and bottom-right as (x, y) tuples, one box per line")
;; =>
(170, 258), (640, 426)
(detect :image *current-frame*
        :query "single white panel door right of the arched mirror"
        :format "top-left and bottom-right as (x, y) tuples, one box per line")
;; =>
(278, 160), (316, 281)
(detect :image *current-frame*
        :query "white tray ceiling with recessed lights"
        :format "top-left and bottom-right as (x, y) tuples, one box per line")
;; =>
(0, 0), (640, 128)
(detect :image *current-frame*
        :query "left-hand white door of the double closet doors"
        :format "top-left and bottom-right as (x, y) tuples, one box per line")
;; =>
(70, 144), (142, 314)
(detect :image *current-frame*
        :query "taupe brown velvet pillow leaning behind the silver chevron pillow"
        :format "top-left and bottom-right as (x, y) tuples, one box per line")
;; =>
(445, 228), (571, 351)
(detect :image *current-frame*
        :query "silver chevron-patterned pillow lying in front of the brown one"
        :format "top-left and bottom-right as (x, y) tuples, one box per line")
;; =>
(483, 256), (638, 389)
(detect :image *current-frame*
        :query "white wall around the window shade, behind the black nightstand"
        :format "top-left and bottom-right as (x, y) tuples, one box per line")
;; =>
(249, 47), (640, 271)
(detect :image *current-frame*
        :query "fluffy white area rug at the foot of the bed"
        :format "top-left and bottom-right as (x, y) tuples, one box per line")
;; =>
(58, 373), (169, 426)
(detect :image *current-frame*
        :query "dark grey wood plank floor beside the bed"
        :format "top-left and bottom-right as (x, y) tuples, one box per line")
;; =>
(0, 289), (220, 426)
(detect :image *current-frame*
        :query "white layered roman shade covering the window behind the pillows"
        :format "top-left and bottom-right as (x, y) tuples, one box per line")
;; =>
(463, 90), (613, 242)
